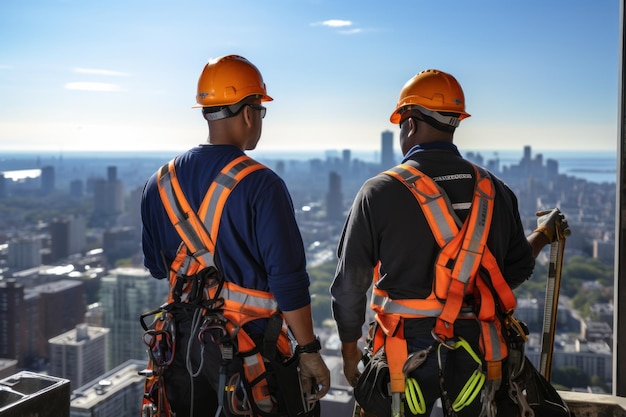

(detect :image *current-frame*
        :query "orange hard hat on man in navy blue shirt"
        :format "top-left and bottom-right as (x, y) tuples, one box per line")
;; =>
(193, 55), (273, 107)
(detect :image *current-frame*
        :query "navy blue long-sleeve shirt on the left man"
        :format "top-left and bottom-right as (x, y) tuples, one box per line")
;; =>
(141, 145), (311, 311)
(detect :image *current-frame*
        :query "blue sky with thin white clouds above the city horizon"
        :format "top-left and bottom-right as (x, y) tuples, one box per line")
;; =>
(0, 0), (620, 152)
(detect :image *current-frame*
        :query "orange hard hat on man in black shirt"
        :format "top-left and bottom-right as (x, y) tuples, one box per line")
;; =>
(389, 69), (470, 127)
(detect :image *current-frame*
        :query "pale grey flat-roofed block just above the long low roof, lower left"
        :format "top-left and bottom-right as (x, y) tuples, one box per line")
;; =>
(48, 323), (109, 389)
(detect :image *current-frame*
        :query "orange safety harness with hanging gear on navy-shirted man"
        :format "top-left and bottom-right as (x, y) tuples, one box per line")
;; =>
(142, 155), (292, 416)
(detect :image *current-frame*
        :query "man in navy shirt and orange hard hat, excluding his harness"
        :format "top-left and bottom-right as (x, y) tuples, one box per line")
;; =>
(141, 55), (330, 416)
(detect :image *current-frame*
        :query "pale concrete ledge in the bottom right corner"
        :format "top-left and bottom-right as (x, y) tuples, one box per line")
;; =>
(559, 391), (626, 417)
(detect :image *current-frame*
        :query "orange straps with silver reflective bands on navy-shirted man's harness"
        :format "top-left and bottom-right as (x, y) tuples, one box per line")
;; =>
(158, 155), (291, 409)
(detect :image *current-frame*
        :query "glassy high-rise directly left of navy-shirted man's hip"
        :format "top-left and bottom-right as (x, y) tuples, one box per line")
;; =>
(100, 268), (169, 369)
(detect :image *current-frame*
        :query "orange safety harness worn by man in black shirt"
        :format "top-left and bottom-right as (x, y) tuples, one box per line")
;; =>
(371, 161), (516, 416)
